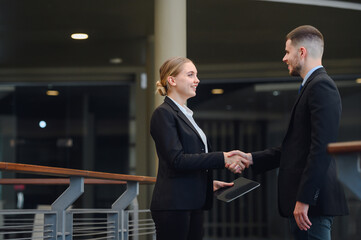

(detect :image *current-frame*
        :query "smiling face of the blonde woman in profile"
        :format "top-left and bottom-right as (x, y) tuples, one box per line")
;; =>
(172, 62), (199, 100)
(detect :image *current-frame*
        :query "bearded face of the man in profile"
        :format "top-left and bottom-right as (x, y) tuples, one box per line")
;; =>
(282, 39), (302, 76)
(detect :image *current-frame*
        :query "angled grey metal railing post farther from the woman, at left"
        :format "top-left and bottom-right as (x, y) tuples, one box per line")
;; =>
(51, 176), (84, 240)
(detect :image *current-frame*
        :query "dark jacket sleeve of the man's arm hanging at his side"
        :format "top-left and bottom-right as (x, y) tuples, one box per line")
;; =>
(297, 79), (341, 205)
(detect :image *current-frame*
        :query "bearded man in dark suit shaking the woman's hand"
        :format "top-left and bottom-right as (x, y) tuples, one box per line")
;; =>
(238, 25), (348, 240)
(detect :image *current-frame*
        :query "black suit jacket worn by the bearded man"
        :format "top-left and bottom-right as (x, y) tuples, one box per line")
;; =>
(252, 68), (348, 217)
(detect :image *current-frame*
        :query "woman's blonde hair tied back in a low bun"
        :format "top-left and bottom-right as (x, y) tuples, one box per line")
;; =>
(156, 57), (192, 96)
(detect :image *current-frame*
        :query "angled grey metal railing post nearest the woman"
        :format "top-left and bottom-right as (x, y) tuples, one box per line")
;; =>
(112, 181), (139, 240)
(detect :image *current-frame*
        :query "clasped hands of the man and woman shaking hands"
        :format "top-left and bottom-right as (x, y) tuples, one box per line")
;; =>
(223, 150), (253, 173)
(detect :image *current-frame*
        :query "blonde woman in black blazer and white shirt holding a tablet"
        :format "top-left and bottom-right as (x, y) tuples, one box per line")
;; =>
(150, 57), (248, 240)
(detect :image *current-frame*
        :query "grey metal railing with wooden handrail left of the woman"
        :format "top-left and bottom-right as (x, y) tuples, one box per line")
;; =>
(0, 162), (155, 240)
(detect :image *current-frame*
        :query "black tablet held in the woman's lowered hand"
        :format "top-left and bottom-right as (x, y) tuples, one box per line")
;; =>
(214, 177), (261, 202)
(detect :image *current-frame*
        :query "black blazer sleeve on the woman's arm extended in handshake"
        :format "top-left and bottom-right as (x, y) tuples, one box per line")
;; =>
(150, 108), (224, 170)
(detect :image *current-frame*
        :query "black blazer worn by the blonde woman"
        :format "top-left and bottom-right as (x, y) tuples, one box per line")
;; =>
(150, 97), (225, 211)
